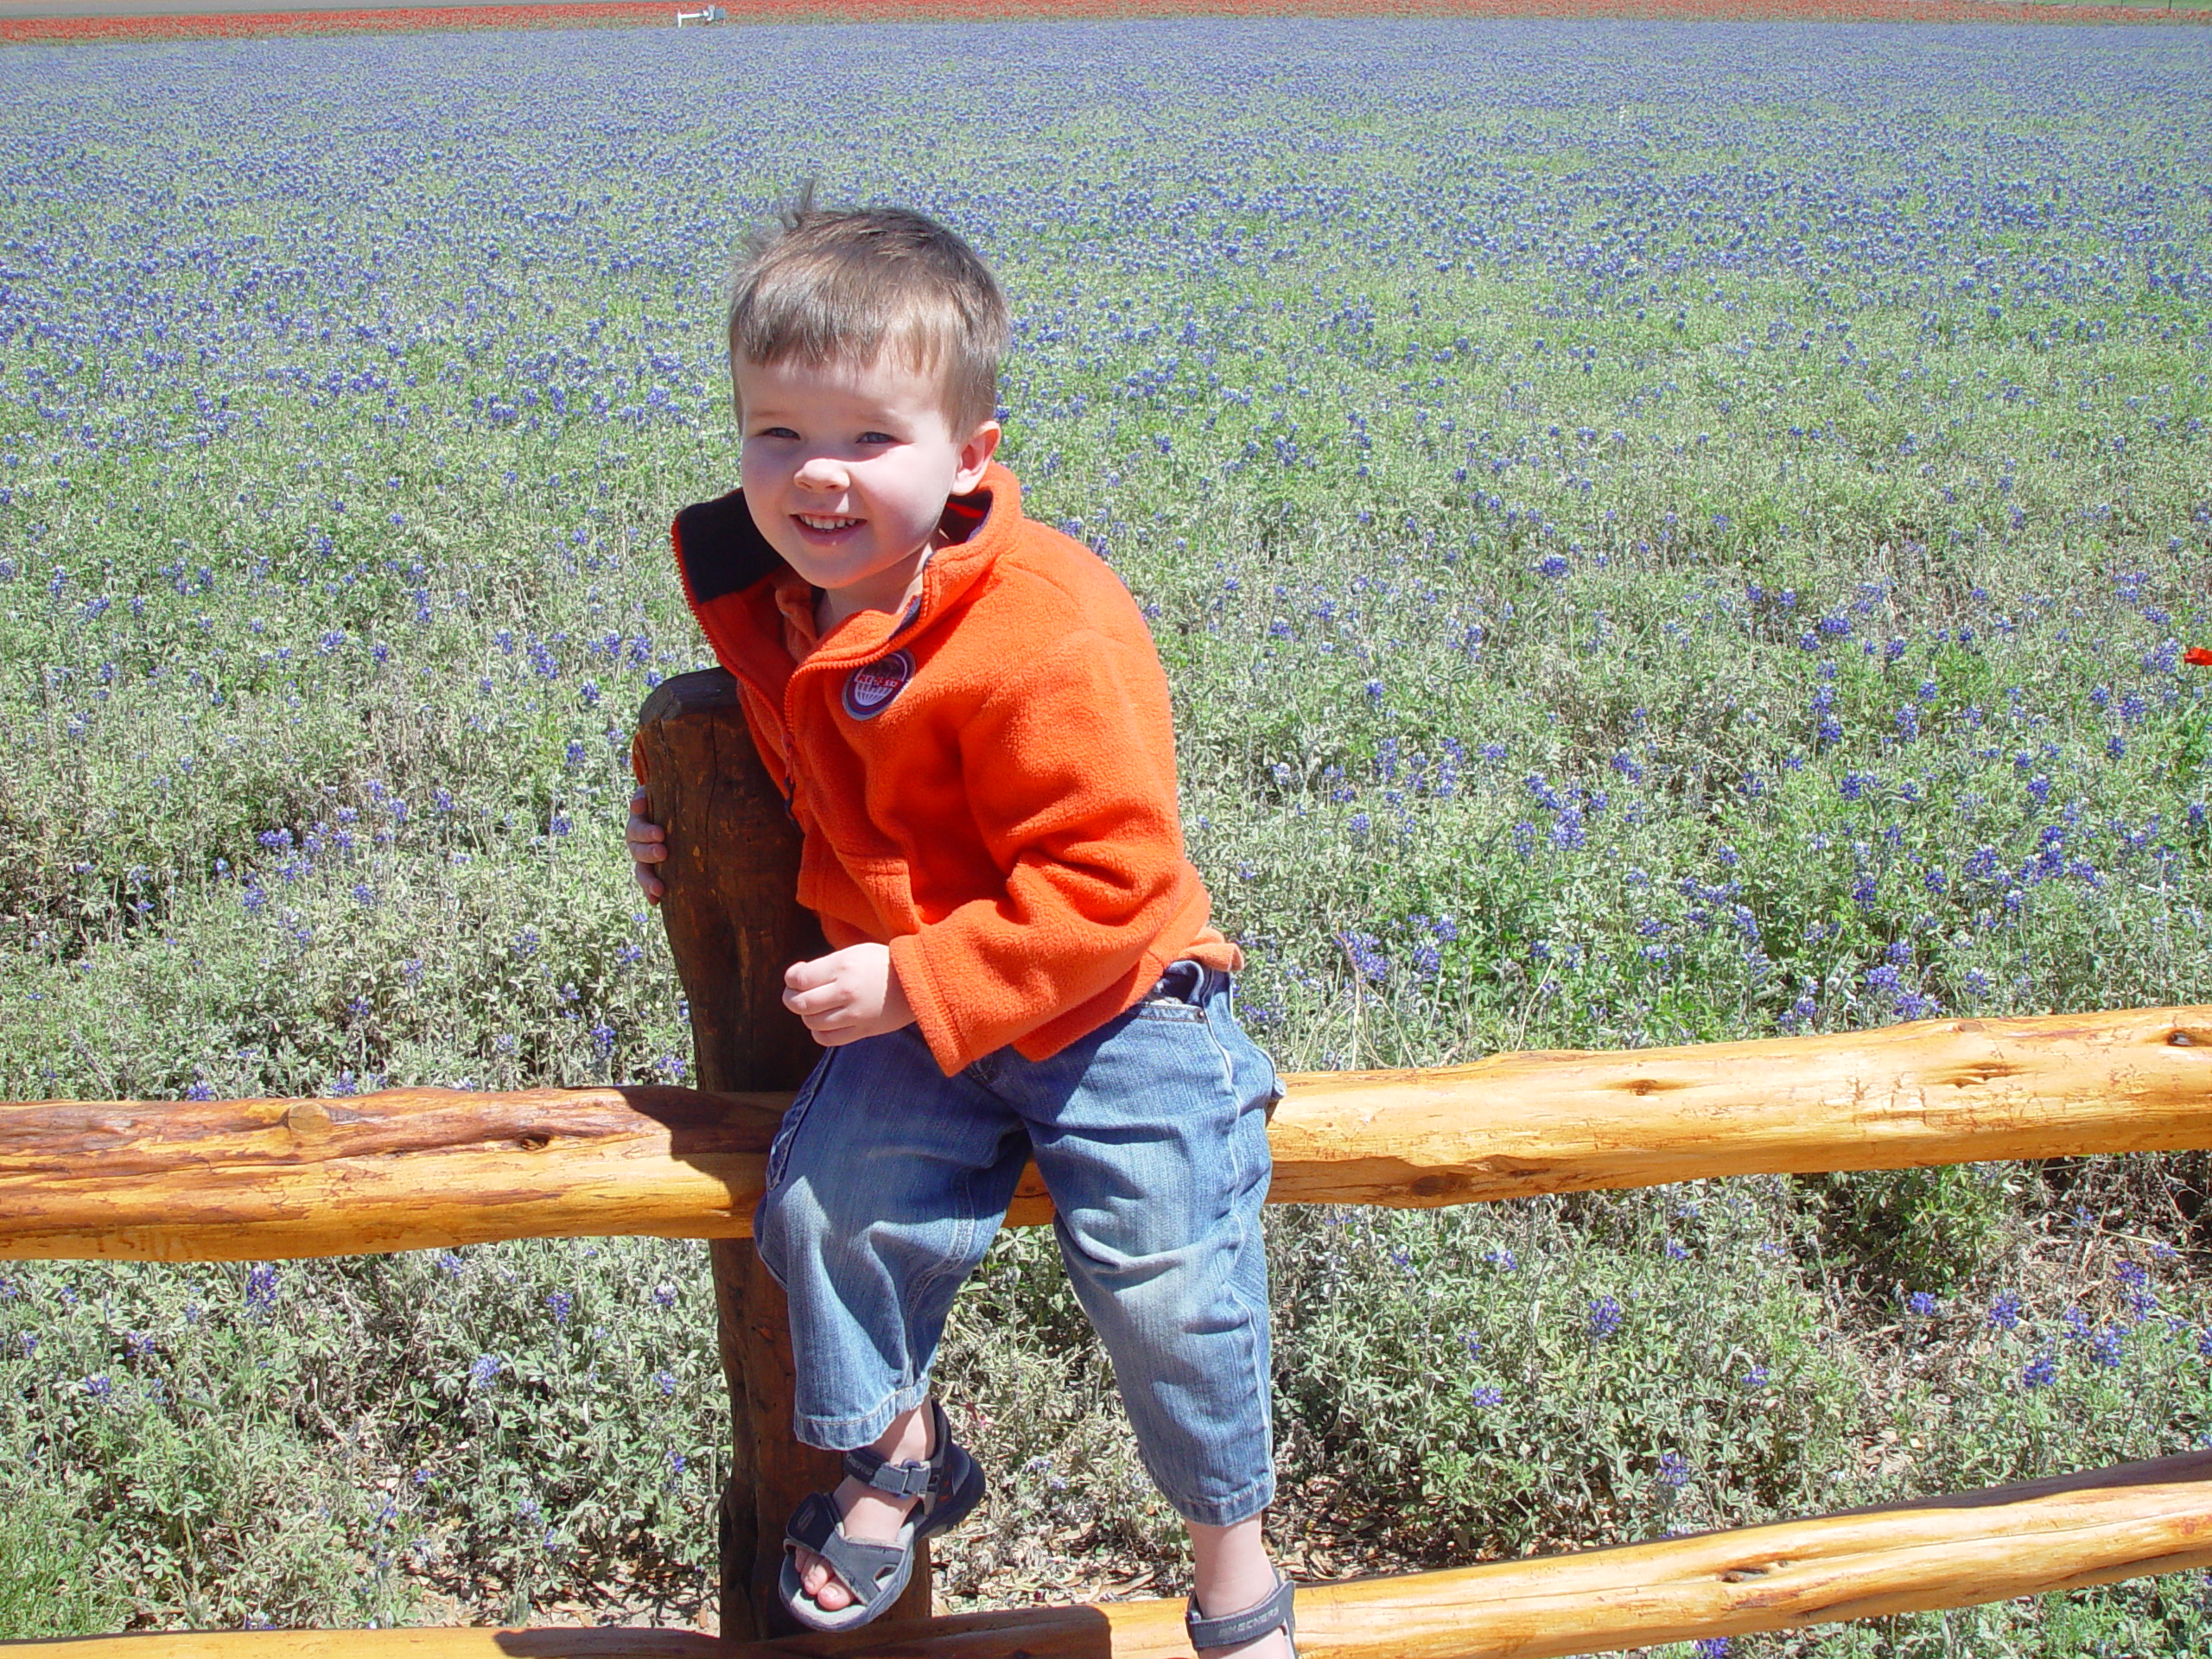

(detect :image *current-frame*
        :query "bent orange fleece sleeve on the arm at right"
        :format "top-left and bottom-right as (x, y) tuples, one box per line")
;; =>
(892, 631), (1197, 1075)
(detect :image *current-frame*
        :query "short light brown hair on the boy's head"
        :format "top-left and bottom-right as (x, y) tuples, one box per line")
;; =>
(730, 186), (1011, 435)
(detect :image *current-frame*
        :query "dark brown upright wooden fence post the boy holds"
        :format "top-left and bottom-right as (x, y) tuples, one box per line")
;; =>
(637, 668), (929, 1639)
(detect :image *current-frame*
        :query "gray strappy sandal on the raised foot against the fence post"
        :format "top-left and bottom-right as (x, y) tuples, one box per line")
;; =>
(777, 1398), (984, 1630)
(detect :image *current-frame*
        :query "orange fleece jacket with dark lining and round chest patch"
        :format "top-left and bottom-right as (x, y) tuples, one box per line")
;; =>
(675, 462), (1243, 1075)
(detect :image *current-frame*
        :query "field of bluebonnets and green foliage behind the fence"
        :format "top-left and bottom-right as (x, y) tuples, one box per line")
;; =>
(0, 10), (2212, 1655)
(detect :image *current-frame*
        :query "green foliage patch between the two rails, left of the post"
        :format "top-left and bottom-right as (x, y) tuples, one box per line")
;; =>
(0, 1239), (728, 1635)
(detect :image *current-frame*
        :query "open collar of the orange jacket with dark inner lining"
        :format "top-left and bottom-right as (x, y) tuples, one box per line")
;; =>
(675, 460), (1022, 664)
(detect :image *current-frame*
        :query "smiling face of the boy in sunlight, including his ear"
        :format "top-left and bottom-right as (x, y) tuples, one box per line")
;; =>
(732, 352), (998, 626)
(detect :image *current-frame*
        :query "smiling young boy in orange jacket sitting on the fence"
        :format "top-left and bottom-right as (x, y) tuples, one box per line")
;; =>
(631, 206), (1292, 1659)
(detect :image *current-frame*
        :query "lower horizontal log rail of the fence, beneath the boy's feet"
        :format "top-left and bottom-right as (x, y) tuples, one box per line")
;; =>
(17, 1451), (2212, 1659)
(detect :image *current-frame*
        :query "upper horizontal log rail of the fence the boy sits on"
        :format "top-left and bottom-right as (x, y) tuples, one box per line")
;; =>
(0, 1002), (2212, 1261)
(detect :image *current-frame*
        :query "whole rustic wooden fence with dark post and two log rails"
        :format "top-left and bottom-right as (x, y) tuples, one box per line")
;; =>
(0, 671), (2212, 1659)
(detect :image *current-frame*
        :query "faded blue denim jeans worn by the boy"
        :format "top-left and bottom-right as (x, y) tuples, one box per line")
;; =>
(752, 963), (1281, 1526)
